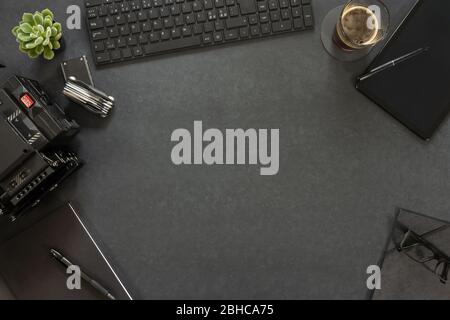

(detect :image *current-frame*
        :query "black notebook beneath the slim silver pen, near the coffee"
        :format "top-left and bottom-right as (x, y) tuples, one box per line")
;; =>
(357, 0), (450, 140)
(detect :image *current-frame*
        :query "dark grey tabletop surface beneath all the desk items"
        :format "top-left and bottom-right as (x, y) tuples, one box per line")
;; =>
(0, 0), (450, 299)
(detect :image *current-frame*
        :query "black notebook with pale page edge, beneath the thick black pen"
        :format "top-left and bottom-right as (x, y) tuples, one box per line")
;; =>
(0, 204), (131, 300)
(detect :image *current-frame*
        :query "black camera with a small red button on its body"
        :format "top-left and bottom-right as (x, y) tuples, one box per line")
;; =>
(0, 76), (81, 219)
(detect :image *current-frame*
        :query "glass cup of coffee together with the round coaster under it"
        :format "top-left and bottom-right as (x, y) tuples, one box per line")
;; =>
(322, 0), (390, 61)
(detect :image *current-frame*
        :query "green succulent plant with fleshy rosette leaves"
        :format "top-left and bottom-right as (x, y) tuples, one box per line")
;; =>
(12, 9), (62, 60)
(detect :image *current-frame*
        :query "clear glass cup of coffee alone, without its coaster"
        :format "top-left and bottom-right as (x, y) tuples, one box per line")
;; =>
(333, 0), (389, 50)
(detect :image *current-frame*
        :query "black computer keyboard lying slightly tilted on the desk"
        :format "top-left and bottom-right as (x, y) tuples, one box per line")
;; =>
(85, 0), (314, 65)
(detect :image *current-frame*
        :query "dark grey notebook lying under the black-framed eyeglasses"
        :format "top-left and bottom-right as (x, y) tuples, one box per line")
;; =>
(369, 209), (450, 300)
